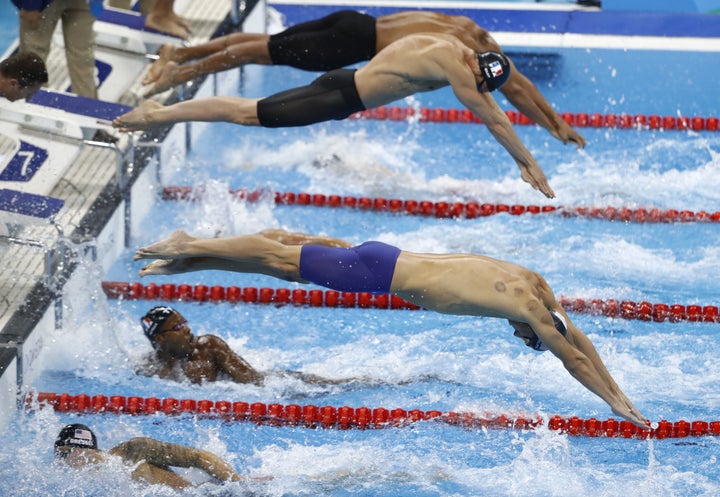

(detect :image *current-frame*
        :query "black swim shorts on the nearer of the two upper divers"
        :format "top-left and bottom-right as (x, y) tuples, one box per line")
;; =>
(257, 69), (365, 128)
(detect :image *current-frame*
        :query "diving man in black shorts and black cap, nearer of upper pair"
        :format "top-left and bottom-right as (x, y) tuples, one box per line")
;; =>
(113, 33), (555, 198)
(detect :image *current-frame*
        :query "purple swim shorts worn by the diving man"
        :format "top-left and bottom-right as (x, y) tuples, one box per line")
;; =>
(300, 242), (400, 293)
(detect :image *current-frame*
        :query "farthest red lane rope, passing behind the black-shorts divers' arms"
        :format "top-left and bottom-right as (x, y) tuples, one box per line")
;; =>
(350, 106), (720, 131)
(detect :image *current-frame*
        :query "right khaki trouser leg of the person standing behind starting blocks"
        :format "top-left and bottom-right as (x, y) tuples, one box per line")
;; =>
(59, 0), (97, 98)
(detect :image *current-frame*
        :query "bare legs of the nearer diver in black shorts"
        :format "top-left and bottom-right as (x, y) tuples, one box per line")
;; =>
(113, 97), (260, 131)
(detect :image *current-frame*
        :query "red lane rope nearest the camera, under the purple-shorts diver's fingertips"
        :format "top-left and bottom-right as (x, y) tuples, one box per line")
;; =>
(25, 392), (720, 439)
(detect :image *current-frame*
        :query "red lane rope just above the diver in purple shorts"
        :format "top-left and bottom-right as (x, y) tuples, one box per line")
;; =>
(162, 185), (720, 223)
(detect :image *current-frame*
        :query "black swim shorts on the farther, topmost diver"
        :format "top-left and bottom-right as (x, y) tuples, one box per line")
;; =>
(268, 10), (377, 71)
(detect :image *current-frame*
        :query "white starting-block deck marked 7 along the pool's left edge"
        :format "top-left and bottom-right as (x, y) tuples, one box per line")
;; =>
(0, 0), (264, 427)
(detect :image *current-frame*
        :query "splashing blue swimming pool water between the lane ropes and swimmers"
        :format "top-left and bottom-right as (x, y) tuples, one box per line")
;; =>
(0, 41), (720, 496)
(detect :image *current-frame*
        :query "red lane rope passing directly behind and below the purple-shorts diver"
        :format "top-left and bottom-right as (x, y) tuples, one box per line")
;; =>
(102, 281), (720, 323)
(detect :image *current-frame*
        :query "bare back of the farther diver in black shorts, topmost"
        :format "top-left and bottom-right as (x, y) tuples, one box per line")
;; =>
(375, 11), (500, 52)
